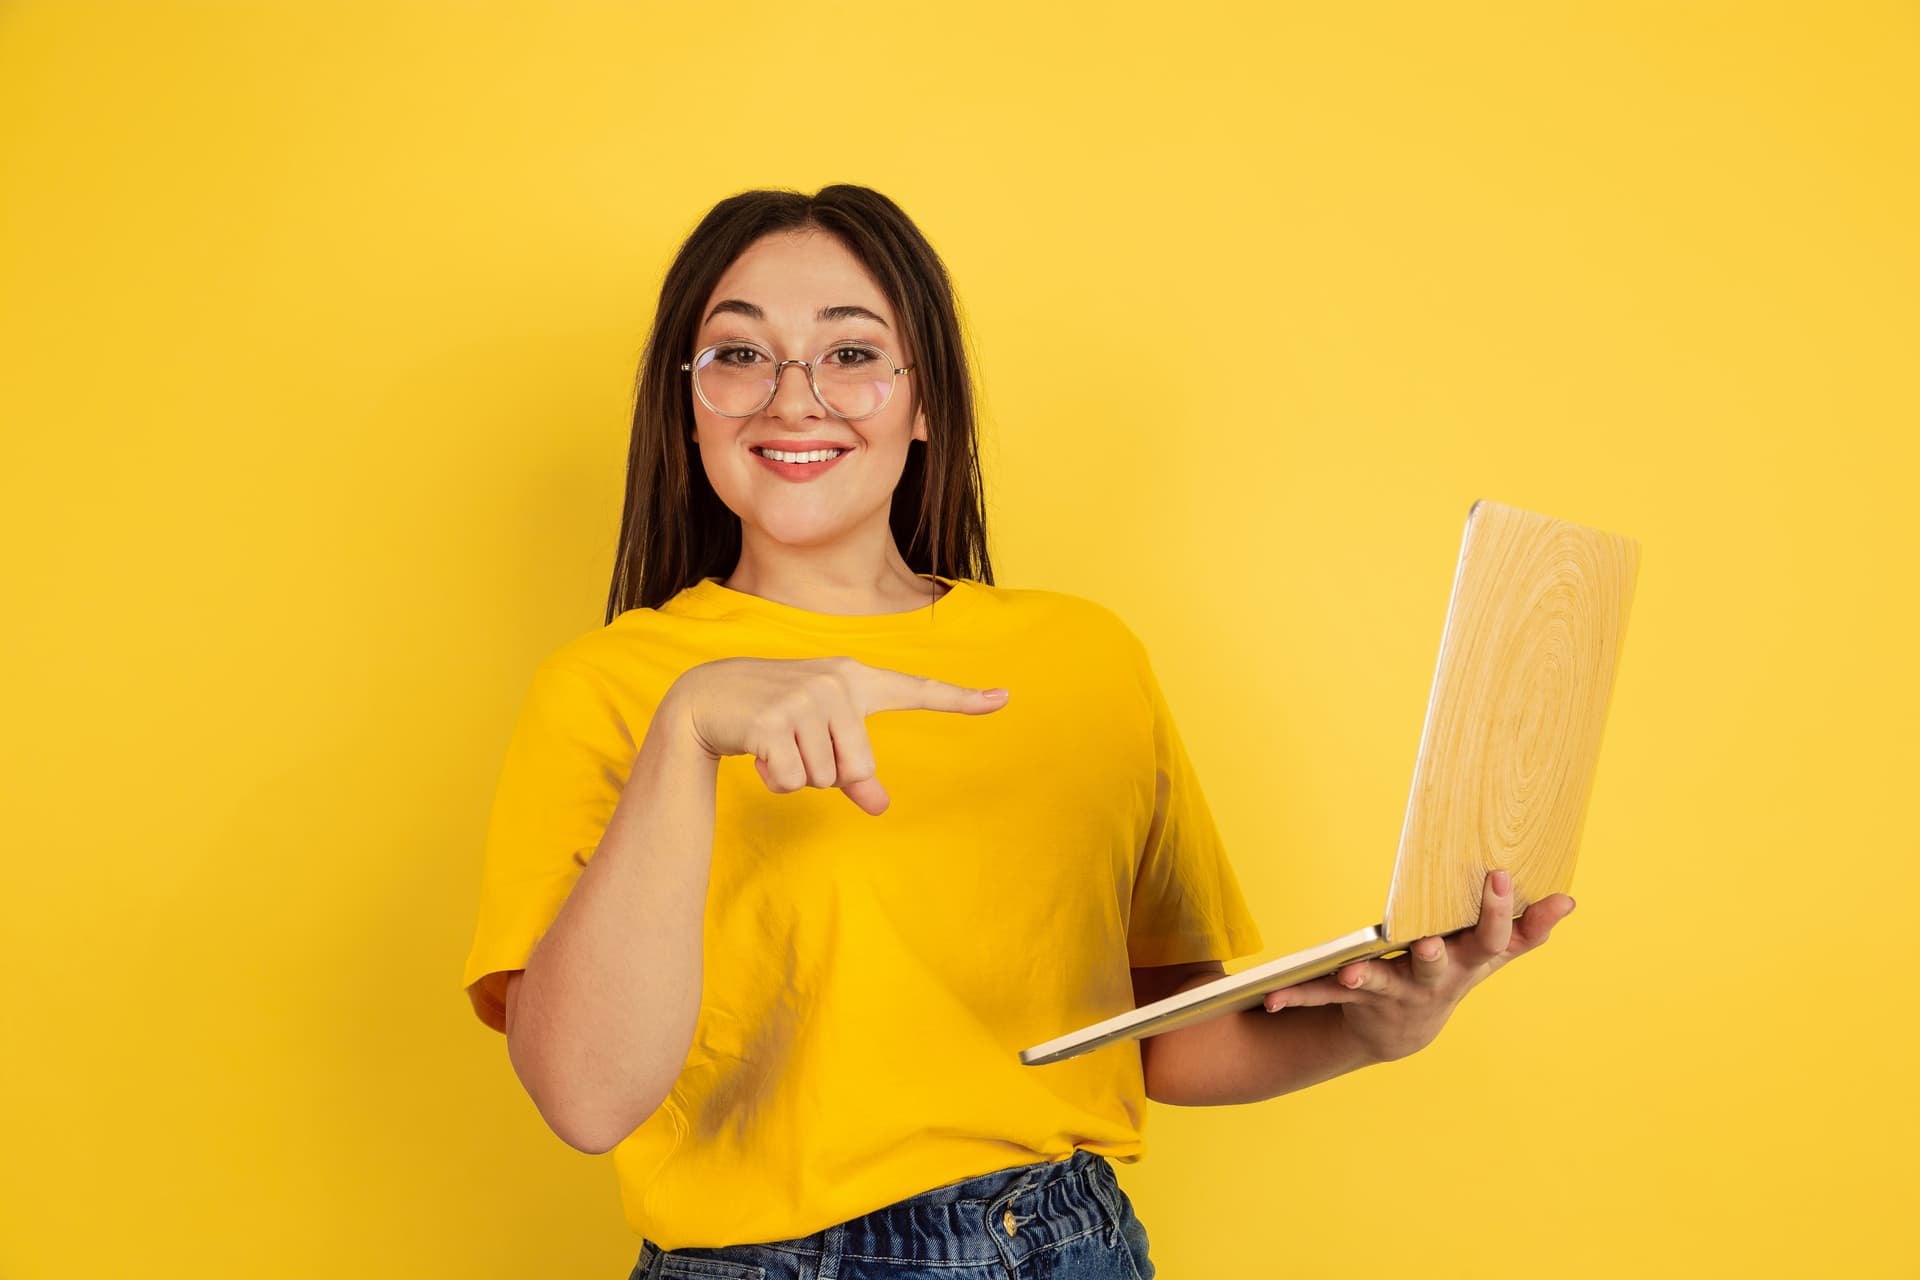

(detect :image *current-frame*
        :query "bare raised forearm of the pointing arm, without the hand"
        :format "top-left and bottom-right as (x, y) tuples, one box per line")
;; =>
(509, 693), (718, 1153)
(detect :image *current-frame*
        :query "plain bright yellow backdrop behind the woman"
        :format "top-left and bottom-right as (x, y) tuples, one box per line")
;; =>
(0, 0), (1920, 1280)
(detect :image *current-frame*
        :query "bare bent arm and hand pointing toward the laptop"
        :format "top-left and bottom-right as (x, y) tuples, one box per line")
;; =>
(507, 656), (1006, 1155)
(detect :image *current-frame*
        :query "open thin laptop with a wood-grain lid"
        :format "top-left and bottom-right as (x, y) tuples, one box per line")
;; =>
(1020, 499), (1640, 1067)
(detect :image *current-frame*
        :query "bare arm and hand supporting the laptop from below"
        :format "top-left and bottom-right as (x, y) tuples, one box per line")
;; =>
(1133, 871), (1572, 1107)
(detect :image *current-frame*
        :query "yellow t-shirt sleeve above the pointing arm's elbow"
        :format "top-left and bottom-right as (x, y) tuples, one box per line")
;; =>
(461, 656), (636, 1032)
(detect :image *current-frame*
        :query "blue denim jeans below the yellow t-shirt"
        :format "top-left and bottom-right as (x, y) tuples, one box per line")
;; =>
(628, 1150), (1154, 1280)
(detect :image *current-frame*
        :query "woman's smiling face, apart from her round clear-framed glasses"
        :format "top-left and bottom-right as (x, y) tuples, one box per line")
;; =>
(691, 232), (927, 547)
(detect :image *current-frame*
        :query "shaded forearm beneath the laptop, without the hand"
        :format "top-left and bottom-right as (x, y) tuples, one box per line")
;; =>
(1140, 983), (1380, 1107)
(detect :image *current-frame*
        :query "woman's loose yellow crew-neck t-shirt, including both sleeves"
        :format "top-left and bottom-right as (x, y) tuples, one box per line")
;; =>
(463, 574), (1263, 1249)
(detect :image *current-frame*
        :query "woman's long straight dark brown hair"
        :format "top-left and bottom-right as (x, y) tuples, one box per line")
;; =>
(607, 182), (993, 622)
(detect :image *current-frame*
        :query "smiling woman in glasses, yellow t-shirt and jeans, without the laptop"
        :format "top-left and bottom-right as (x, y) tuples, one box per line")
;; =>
(465, 184), (1567, 1280)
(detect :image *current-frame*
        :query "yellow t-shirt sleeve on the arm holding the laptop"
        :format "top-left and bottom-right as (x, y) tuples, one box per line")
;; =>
(1127, 631), (1265, 969)
